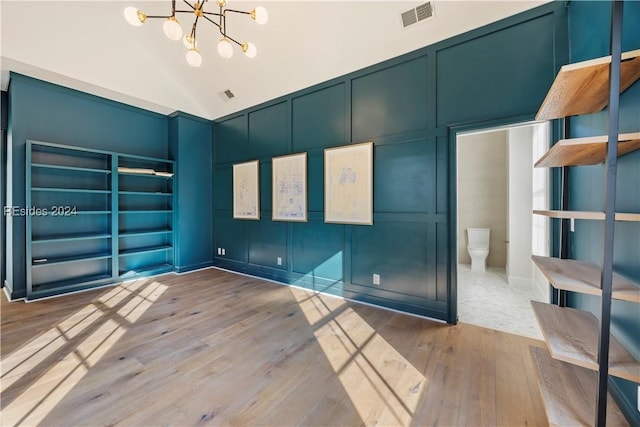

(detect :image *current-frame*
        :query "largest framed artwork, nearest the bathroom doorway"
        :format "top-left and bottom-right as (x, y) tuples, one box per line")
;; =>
(324, 142), (373, 225)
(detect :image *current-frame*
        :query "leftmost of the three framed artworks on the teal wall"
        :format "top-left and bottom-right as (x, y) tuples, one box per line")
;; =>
(233, 160), (260, 220)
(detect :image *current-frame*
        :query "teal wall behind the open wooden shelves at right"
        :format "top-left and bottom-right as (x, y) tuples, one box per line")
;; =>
(569, 1), (640, 425)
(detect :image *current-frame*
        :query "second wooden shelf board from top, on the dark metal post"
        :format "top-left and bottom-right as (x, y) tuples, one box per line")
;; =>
(534, 132), (640, 168)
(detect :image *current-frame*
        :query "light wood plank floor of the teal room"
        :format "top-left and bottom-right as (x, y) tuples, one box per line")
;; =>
(0, 269), (547, 427)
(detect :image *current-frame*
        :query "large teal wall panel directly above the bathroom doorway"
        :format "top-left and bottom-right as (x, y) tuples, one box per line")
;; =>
(436, 14), (559, 125)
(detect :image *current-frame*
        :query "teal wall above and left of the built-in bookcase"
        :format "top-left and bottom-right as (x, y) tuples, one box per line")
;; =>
(7, 74), (168, 298)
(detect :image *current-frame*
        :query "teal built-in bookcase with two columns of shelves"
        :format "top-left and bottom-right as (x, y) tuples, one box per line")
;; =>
(23, 141), (173, 300)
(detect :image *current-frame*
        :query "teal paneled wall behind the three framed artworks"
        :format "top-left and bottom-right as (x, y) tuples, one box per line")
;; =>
(213, 2), (568, 322)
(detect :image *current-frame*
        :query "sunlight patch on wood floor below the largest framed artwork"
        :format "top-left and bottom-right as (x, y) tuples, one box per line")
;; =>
(292, 289), (427, 426)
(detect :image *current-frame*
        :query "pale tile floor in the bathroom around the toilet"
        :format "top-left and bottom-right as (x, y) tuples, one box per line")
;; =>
(458, 264), (543, 339)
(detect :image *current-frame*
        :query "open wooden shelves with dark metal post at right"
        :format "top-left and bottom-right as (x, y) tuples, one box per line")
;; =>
(532, 8), (640, 427)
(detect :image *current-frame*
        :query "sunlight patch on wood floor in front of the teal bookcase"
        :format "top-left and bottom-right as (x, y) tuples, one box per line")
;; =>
(0, 280), (167, 426)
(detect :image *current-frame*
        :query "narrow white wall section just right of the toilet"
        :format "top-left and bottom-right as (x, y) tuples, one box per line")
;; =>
(507, 126), (534, 288)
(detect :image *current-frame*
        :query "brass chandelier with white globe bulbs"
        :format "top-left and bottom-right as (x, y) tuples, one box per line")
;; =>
(124, 0), (269, 67)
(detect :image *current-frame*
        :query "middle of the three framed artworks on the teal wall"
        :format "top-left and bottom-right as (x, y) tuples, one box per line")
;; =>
(271, 153), (307, 222)
